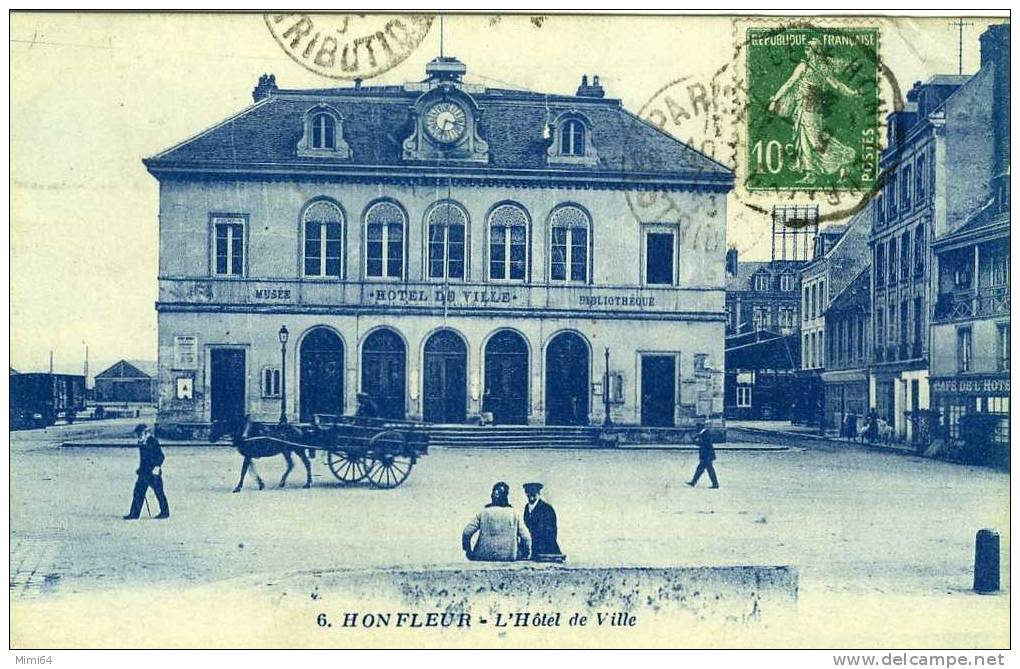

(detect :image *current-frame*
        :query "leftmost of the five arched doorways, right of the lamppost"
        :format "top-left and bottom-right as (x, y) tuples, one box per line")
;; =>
(298, 327), (344, 422)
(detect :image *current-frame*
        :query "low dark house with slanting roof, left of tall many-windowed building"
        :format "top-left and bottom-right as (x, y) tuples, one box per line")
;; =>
(821, 267), (871, 429)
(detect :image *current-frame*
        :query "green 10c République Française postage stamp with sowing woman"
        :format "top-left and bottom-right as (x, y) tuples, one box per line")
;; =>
(746, 27), (878, 191)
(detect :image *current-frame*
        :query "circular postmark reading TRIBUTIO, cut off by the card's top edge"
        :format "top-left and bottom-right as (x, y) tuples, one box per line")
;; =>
(265, 13), (435, 80)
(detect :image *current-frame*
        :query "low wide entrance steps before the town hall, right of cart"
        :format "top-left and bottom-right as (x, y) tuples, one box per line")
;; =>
(428, 425), (602, 449)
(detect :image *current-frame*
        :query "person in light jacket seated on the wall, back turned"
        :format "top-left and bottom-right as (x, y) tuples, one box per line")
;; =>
(461, 481), (531, 562)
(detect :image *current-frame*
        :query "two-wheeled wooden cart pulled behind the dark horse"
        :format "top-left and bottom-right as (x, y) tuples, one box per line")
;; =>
(302, 414), (428, 487)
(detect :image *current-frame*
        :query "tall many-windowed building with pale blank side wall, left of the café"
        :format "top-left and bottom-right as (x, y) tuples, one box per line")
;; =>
(870, 25), (1009, 441)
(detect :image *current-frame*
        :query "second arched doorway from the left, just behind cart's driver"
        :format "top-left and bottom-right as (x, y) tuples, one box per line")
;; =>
(361, 329), (407, 420)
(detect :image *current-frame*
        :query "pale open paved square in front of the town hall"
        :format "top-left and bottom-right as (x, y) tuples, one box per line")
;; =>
(10, 421), (1010, 645)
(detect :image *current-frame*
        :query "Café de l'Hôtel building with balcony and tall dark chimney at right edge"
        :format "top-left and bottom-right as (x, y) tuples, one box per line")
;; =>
(931, 24), (1010, 462)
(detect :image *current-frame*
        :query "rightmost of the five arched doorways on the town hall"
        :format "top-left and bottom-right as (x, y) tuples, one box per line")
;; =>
(546, 332), (592, 425)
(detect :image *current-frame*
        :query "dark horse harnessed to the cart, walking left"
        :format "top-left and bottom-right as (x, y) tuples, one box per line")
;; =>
(209, 416), (314, 493)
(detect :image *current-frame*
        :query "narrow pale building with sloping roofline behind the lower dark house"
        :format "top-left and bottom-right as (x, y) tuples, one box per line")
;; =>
(793, 203), (872, 426)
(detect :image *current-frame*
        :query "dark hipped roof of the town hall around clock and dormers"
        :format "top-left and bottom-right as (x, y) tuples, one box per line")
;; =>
(145, 81), (732, 185)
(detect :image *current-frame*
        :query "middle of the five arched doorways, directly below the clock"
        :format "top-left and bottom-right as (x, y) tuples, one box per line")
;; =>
(423, 329), (467, 423)
